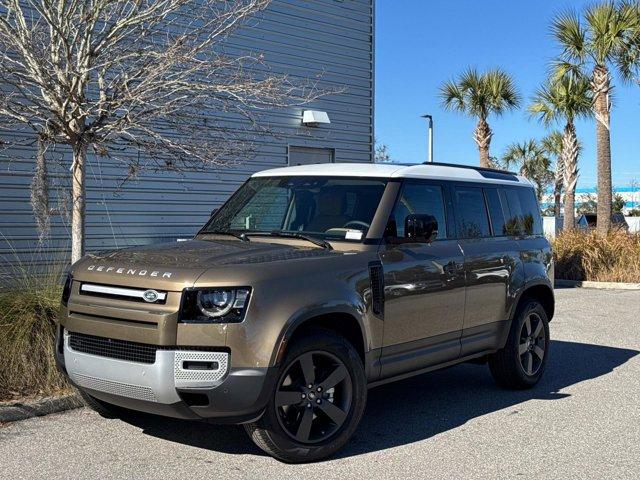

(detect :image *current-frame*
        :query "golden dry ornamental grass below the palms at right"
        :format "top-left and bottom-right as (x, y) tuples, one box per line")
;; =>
(553, 231), (640, 283)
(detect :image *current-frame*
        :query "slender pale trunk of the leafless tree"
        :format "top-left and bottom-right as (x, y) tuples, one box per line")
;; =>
(71, 142), (87, 263)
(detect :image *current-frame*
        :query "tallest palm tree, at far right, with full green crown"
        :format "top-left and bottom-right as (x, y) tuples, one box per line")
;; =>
(552, 0), (640, 233)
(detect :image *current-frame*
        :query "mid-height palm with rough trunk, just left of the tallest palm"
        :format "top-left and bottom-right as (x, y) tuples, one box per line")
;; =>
(529, 70), (592, 230)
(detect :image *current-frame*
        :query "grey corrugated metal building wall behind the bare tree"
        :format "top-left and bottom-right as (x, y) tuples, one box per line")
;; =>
(0, 0), (374, 272)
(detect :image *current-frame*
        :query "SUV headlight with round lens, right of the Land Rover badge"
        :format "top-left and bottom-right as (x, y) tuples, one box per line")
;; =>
(180, 288), (251, 323)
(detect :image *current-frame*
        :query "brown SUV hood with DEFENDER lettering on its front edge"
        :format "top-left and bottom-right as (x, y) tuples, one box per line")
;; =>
(72, 239), (340, 290)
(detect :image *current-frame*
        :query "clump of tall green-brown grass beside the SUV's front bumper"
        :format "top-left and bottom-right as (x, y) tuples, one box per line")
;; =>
(0, 249), (70, 401)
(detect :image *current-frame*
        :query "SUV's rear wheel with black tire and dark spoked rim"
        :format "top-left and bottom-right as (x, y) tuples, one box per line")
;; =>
(489, 299), (550, 390)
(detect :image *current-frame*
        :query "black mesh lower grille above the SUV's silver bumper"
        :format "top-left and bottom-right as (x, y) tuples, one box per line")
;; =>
(69, 332), (158, 363)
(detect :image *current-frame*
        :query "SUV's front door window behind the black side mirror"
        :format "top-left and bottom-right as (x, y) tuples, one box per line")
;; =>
(387, 183), (447, 239)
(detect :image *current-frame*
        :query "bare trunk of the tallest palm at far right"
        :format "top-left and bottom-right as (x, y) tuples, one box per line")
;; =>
(592, 66), (613, 234)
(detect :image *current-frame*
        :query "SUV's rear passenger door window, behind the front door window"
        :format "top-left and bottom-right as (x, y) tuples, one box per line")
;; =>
(454, 187), (490, 238)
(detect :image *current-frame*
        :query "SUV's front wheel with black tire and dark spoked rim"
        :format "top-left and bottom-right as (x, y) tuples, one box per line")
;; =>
(244, 329), (367, 463)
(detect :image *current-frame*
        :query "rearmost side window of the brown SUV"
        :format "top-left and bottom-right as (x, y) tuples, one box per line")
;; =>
(502, 188), (542, 235)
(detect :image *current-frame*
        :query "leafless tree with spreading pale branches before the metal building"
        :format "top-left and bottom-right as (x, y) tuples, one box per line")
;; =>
(0, 0), (326, 262)
